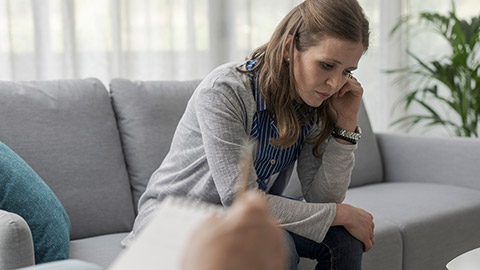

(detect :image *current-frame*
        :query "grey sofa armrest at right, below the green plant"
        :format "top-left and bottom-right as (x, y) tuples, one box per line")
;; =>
(377, 134), (480, 190)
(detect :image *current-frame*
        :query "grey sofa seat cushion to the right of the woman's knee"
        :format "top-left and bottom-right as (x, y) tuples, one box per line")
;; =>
(345, 183), (480, 270)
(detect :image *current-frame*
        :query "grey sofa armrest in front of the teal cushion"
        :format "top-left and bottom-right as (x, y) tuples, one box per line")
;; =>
(0, 209), (35, 269)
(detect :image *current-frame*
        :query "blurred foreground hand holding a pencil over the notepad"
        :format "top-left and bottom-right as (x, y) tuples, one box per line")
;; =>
(183, 191), (287, 270)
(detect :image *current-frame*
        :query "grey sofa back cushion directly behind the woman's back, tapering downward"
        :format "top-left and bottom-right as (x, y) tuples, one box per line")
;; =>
(110, 79), (200, 211)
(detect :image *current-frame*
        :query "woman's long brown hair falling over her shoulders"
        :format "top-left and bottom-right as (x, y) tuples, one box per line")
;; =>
(240, 0), (369, 157)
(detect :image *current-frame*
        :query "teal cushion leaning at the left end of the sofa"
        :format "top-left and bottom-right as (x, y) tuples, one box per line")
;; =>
(0, 142), (70, 264)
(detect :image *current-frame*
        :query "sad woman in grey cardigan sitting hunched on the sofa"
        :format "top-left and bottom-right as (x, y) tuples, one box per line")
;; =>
(123, 0), (375, 269)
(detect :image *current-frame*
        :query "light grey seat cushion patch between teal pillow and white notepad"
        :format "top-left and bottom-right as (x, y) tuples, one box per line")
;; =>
(70, 233), (128, 269)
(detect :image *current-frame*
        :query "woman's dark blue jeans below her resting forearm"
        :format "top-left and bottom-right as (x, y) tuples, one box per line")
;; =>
(286, 226), (363, 270)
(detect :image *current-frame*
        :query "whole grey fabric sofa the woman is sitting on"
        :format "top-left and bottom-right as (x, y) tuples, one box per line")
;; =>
(0, 79), (480, 270)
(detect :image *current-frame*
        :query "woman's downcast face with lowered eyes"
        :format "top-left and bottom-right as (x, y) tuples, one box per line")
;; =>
(294, 37), (364, 107)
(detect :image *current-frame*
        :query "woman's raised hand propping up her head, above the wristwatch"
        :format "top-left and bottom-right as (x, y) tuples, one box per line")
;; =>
(331, 76), (363, 131)
